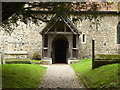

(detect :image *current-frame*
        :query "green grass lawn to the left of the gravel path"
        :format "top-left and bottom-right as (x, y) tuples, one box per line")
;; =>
(2, 64), (46, 88)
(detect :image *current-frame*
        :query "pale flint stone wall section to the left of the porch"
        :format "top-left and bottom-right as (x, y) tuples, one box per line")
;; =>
(0, 21), (46, 57)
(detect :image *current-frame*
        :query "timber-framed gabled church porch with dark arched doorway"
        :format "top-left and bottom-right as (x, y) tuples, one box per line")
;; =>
(40, 14), (81, 64)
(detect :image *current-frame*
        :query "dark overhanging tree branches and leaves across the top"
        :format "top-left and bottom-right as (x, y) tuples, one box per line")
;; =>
(2, 2), (116, 32)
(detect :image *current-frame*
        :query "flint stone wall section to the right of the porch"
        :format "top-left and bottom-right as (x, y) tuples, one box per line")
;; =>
(75, 14), (120, 57)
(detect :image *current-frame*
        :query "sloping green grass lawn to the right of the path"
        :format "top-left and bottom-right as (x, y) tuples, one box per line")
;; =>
(72, 59), (120, 88)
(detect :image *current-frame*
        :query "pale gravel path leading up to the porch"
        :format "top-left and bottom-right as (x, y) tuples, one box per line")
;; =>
(39, 64), (84, 88)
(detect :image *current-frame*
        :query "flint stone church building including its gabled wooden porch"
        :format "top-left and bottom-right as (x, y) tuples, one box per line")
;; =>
(0, 11), (120, 64)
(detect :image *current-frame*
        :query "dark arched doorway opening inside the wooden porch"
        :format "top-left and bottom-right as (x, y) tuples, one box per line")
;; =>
(52, 36), (68, 63)
